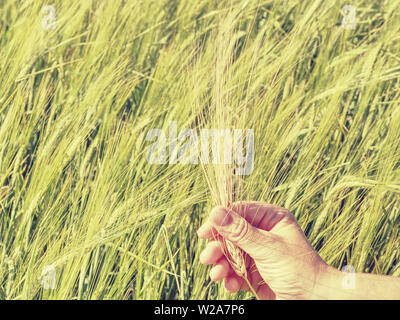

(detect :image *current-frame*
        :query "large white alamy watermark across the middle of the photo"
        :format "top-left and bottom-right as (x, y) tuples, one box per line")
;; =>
(146, 121), (254, 175)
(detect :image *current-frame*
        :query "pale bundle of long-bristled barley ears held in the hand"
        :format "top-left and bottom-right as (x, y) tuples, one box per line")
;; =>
(198, 10), (259, 299)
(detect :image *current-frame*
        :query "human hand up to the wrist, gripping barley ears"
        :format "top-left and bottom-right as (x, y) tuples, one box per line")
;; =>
(198, 202), (329, 299)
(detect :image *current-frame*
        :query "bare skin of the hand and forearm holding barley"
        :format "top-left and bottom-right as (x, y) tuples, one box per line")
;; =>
(198, 202), (400, 299)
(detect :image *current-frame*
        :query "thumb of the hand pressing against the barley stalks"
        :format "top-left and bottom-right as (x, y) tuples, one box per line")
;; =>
(209, 207), (273, 259)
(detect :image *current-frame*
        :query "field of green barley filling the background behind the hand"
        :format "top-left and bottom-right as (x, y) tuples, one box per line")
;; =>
(0, 0), (400, 299)
